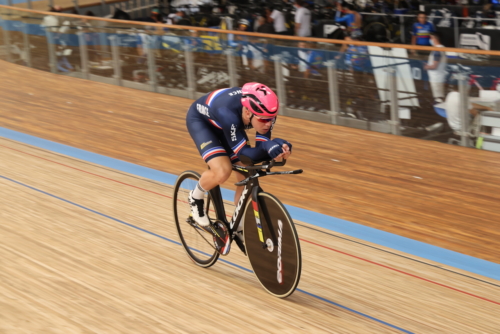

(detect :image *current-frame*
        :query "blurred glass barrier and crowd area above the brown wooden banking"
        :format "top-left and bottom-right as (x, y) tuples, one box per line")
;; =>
(0, 0), (500, 151)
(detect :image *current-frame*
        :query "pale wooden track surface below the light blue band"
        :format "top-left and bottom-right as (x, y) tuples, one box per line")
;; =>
(0, 139), (500, 334)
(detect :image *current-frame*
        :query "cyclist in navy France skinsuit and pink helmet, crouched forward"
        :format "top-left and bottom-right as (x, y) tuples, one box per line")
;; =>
(186, 82), (292, 230)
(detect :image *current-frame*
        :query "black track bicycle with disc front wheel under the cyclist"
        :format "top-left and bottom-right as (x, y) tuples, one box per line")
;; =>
(173, 157), (302, 298)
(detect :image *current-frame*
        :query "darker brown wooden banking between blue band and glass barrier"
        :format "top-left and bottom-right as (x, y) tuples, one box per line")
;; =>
(0, 61), (500, 263)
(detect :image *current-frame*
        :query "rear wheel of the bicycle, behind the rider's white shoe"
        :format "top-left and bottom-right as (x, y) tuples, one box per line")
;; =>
(173, 171), (219, 268)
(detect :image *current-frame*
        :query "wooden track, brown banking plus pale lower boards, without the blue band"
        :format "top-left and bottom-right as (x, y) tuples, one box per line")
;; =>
(0, 62), (500, 333)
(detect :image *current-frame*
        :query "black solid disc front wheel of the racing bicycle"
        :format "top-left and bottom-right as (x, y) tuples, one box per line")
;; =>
(243, 192), (302, 298)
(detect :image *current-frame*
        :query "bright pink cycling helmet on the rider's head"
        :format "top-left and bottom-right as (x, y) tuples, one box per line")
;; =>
(241, 82), (280, 117)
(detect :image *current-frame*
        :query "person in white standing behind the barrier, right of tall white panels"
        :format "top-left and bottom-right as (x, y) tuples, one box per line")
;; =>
(424, 33), (447, 103)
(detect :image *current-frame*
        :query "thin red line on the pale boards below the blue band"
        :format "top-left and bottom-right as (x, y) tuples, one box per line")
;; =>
(0, 145), (500, 305)
